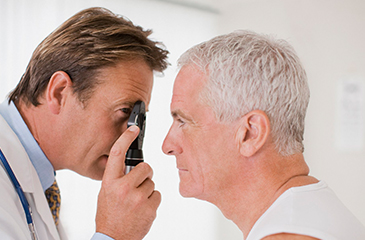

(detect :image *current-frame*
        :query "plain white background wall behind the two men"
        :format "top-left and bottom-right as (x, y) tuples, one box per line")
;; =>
(0, 0), (365, 240)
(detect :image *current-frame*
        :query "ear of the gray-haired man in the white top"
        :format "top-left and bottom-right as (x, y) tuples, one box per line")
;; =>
(236, 110), (270, 157)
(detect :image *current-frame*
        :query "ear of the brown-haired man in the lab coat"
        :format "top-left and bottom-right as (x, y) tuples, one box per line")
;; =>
(45, 71), (72, 114)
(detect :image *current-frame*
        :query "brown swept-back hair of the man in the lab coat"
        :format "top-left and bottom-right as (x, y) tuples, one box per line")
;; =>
(9, 8), (168, 106)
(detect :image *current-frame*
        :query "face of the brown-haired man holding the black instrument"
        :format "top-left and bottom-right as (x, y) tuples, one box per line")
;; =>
(55, 60), (153, 179)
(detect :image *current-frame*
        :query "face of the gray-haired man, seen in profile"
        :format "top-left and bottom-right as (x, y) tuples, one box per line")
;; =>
(162, 66), (234, 202)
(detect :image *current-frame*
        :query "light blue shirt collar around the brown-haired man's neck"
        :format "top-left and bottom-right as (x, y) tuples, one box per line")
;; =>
(0, 100), (55, 191)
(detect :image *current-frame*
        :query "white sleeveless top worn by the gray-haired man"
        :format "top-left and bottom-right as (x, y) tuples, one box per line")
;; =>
(246, 181), (365, 240)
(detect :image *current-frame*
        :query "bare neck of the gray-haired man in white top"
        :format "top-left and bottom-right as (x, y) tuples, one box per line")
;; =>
(212, 151), (318, 237)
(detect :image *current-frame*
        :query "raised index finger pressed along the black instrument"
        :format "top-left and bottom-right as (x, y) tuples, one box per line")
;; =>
(103, 126), (139, 181)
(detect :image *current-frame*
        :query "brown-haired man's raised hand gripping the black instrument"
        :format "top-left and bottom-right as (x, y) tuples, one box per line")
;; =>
(96, 126), (161, 240)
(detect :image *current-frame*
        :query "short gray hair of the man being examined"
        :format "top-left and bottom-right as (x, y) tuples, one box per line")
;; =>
(178, 30), (310, 156)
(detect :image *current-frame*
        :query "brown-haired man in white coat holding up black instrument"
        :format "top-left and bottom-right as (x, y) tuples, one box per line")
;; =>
(0, 8), (168, 240)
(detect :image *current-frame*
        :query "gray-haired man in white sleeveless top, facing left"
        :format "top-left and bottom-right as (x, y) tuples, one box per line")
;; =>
(162, 31), (365, 240)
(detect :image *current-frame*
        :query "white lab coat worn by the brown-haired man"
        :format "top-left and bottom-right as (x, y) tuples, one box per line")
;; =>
(0, 115), (66, 240)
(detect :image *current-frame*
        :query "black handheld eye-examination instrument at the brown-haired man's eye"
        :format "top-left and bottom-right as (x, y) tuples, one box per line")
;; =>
(125, 101), (146, 174)
